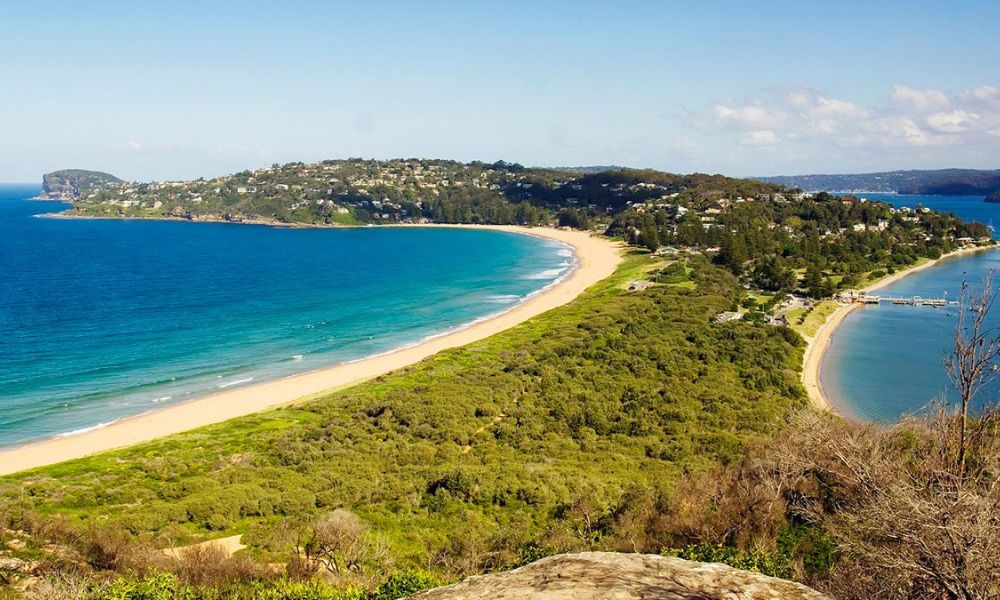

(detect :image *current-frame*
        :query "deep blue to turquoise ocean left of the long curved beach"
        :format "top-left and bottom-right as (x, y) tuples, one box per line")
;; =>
(0, 185), (573, 445)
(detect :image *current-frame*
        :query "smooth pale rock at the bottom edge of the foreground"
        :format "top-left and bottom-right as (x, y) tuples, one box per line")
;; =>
(412, 552), (828, 600)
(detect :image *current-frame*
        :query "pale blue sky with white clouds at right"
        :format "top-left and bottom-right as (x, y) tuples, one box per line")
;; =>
(0, 0), (1000, 182)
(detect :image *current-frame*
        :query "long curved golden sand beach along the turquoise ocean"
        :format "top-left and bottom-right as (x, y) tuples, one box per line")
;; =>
(0, 225), (621, 475)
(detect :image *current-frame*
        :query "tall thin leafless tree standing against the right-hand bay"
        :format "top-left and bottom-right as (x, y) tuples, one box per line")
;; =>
(945, 269), (1000, 481)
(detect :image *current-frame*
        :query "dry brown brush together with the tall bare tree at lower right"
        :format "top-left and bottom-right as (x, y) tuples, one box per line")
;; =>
(667, 270), (1000, 599)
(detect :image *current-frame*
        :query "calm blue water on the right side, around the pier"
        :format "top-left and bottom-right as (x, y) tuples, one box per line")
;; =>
(821, 194), (1000, 420)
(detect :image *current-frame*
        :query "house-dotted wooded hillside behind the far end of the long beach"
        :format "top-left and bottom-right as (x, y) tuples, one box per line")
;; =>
(60, 159), (783, 229)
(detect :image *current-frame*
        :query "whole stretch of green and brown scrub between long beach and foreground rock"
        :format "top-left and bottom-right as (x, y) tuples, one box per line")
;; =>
(7, 245), (1000, 600)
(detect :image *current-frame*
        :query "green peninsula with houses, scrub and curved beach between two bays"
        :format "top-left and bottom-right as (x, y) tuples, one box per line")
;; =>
(0, 160), (992, 598)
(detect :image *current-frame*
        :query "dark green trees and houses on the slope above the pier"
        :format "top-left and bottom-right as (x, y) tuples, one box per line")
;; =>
(608, 193), (989, 298)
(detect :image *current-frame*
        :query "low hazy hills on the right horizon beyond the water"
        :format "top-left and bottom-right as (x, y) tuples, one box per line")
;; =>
(756, 169), (1000, 196)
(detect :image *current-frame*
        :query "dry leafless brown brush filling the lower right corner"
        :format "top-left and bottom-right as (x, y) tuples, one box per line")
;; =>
(757, 407), (1000, 600)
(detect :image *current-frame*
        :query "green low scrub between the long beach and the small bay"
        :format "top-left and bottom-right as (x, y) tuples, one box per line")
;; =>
(0, 254), (804, 573)
